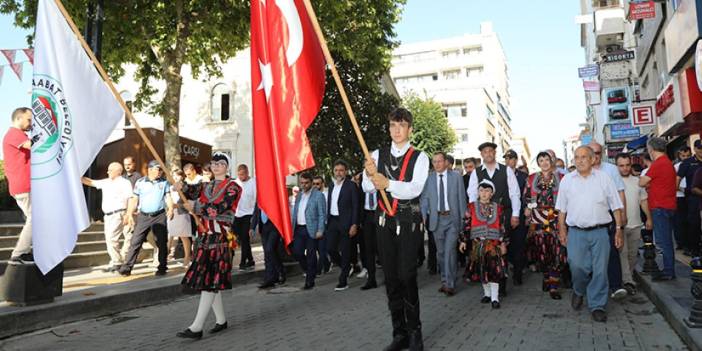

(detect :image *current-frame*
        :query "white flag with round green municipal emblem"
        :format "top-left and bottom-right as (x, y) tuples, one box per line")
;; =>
(31, 0), (123, 274)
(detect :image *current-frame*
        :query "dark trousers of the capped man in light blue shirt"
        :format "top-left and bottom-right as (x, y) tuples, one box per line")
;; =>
(124, 212), (168, 271)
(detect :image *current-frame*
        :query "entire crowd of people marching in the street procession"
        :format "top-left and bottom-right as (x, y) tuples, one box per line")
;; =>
(3, 108), (680, 350)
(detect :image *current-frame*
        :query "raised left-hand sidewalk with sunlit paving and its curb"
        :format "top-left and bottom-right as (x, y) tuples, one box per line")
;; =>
(0, 245), (299, 339)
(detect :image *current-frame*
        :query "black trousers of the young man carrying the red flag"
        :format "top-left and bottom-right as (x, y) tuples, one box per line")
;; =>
(375, 215), (424, 336)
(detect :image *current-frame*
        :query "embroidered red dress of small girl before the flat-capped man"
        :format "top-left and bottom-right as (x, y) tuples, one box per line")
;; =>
(468, 202), (507, 283)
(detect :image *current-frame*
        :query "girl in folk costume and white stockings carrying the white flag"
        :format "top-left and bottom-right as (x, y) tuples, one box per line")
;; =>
(177, 152), (241, 339)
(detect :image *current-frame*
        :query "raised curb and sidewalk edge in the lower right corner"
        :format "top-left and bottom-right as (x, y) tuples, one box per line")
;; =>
(634, 261), (702, 351)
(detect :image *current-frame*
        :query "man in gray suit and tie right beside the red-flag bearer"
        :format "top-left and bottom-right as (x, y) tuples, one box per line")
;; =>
(420, 151), (466, 296)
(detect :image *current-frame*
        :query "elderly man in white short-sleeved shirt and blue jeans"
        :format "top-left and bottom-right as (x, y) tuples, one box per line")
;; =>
(556, 146), (624, 322)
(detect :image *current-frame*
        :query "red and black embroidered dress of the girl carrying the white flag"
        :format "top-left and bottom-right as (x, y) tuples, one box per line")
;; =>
(181, 177), (242, 291)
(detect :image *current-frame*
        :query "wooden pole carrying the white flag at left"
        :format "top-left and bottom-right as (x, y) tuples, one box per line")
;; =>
(54, 0), (200, 227)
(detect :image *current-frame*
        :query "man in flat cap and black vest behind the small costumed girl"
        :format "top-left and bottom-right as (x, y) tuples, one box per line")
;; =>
(467, 142), (521, 294)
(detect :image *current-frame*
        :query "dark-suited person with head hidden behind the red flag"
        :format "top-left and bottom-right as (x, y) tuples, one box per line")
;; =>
(249, 204), (285, 289)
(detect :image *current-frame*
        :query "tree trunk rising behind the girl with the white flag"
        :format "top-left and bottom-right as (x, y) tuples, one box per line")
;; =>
(162, 64), (183, 171)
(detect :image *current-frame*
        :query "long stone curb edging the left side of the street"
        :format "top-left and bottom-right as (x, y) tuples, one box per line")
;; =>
(0, 262), (302, 340)
